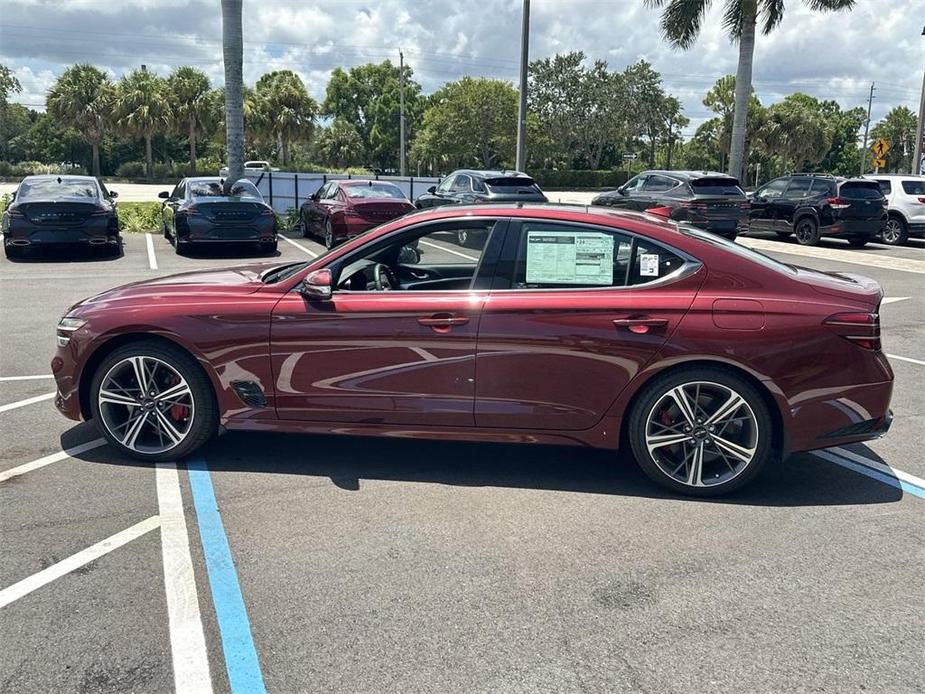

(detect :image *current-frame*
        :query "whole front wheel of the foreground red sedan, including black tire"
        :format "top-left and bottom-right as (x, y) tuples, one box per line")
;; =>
(90, 340), (218, 462)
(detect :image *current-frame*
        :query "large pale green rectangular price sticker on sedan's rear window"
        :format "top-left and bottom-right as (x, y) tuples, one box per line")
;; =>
(526, 231), (614, 286)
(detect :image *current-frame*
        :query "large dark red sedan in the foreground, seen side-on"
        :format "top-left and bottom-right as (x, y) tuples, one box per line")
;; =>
(52, 205), (893, 495)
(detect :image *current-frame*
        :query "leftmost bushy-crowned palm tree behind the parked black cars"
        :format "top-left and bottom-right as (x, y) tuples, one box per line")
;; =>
(45, 64), (115, 176)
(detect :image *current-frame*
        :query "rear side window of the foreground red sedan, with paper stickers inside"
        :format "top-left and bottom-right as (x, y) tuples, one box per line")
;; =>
(512, 221), (684, 289)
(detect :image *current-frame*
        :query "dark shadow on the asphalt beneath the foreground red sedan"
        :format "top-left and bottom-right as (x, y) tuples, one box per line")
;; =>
(61, 423), (903, 507)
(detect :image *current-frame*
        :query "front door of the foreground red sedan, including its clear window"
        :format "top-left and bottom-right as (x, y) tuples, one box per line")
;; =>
(271, 220), (506, 426)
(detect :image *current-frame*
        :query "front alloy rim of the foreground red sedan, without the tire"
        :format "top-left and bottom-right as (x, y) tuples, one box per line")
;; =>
(97, 356), (196, 454)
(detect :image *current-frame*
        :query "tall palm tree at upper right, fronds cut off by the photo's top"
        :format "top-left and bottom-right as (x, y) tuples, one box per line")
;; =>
(645, 0), (856, 178)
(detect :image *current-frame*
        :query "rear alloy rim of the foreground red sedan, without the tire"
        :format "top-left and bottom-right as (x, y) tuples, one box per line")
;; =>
(645, 381), (759, 487)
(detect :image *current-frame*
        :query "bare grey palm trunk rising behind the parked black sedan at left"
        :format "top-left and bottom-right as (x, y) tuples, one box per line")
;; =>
(222, 0), (244, 192)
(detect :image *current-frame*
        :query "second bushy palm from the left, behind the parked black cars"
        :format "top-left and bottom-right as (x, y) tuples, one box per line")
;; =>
(113, 67), (170, 178)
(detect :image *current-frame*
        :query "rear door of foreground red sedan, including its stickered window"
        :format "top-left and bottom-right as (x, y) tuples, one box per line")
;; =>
(475, 220), (703, 430)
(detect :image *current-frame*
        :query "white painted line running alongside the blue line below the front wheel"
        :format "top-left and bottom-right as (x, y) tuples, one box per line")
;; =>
(156, 463), (212, 694)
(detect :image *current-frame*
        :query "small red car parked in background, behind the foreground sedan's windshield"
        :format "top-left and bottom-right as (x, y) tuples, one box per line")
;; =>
(299, 179), (414, 248)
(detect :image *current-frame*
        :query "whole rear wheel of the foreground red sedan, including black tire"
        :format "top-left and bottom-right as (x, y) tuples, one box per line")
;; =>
(627, 366), (775, 496)
